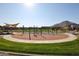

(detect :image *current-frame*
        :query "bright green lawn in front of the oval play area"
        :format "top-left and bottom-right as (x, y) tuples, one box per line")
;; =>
(0, 38), (79, 55)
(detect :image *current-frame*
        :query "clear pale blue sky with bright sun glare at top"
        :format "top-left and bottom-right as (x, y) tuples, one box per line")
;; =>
(0, 3), (79, 27)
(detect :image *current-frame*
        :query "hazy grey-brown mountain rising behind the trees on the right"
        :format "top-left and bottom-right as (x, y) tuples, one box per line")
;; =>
(53, 21), (79, 28)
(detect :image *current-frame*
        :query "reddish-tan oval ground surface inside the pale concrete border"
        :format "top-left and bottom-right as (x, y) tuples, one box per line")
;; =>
(12, 33), (68, 41)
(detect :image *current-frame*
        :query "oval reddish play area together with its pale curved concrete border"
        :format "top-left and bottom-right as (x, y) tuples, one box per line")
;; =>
(3, 33), (77, 43)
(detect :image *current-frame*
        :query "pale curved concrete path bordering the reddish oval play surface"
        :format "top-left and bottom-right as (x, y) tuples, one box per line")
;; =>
(3, 33), (77, 43)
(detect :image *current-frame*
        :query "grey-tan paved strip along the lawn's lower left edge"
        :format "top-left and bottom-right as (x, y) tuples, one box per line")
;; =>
(0, 51), (42, 56)
